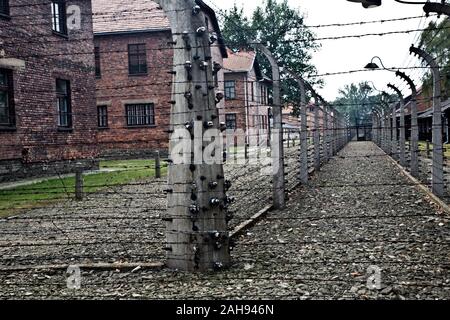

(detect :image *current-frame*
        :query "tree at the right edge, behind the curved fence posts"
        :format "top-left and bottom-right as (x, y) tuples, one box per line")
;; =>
(420, 17), (450, 98)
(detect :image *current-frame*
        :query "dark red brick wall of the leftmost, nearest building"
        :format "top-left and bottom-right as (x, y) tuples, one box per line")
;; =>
(0, 0), (97, 163)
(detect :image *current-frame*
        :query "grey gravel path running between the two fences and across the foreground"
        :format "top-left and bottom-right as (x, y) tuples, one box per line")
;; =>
(0, 142), (450, 299)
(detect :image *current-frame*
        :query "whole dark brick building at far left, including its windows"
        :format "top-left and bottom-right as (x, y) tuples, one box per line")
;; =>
(0, 0), (97, 181)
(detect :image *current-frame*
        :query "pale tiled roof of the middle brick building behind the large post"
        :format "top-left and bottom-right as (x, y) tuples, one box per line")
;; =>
(92, 0), (227, 58)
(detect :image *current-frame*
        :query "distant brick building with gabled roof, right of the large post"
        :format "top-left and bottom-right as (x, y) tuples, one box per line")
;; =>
(224, 50), (271, 145)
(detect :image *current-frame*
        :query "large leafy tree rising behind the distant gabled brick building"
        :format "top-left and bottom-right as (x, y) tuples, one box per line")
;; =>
(222, 0), (322, 112)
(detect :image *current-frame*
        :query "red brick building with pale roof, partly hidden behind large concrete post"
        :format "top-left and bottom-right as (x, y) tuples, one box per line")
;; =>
(93, 0), (227, 157)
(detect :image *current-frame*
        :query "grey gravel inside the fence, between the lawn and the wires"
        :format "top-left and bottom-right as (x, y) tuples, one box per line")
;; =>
(0, 149), (282, 267)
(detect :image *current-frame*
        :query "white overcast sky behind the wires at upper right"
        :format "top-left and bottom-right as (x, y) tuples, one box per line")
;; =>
(209, 0), (442, 101)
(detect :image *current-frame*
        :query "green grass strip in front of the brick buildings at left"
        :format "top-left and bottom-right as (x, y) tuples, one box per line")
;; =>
(0, 160), (167, 217)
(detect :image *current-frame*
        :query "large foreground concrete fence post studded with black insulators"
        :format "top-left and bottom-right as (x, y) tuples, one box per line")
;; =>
(156, 0), (231, 272)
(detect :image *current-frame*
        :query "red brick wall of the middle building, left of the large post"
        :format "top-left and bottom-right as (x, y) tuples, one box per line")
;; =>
(95, 32), (173, 153)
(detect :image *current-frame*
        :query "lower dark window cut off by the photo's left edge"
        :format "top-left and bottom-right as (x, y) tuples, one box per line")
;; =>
(0, 69), (15, 127)
